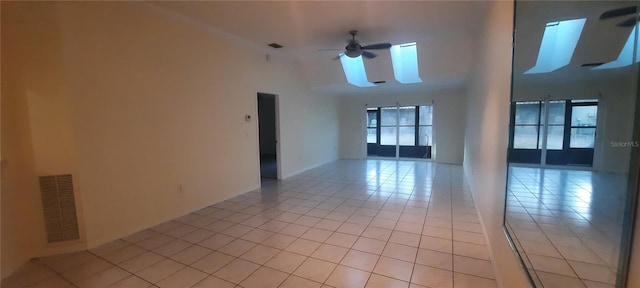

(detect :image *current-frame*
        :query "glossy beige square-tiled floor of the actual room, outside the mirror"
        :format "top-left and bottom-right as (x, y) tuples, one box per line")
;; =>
(2, 160), (496, 288)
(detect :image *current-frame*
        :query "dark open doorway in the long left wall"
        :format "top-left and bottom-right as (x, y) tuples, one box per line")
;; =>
(258, 93), (278, 179)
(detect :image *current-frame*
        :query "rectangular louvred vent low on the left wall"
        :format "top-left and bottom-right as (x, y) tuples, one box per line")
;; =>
(40, 174), (80, 243)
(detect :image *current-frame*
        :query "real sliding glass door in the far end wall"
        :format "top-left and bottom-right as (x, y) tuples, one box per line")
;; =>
(366, 105), (433, 159)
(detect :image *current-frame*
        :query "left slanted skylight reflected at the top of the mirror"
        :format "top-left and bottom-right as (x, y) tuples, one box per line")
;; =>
(524, 18), (587, 74)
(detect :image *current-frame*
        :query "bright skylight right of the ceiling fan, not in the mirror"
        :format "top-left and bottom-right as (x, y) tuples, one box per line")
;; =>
(390, 42), (422, 84)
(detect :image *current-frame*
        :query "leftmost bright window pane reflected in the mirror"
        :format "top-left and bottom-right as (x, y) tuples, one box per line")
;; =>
(513, 101), (541, 149)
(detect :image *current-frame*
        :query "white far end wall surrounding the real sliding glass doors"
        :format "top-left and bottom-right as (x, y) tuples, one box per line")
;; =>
(340, 90), (465, 164)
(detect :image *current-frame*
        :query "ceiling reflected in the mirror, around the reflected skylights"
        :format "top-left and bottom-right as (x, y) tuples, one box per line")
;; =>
(513, 1), (638, 85)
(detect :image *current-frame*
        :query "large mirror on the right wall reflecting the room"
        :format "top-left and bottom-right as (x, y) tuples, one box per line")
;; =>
(504, 0), (640, 287)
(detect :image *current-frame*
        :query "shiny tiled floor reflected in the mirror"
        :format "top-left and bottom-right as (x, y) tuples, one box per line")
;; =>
(507, 167), (626, 287)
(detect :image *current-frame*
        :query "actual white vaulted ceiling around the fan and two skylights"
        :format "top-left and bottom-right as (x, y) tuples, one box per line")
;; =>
(154, 1), (487, 95)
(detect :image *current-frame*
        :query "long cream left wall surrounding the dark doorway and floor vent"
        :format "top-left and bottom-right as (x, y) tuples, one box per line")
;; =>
(1, 2), (339, 277)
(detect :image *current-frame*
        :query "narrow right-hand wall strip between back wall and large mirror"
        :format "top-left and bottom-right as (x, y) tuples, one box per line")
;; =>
(464, 1), (529, 287)
